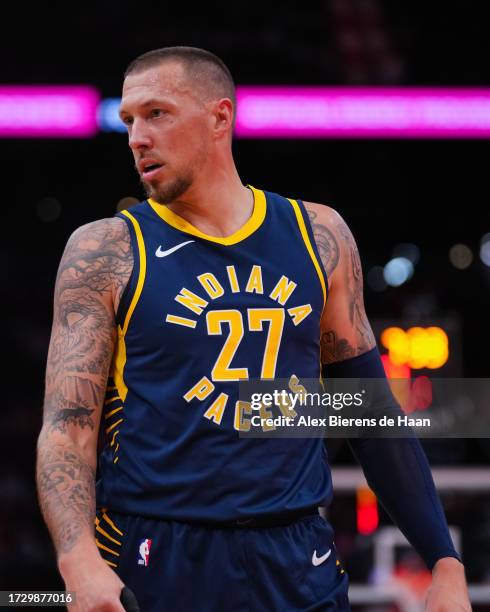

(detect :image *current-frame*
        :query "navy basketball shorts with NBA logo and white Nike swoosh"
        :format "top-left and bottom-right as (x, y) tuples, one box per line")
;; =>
(96, 510), (350, 612)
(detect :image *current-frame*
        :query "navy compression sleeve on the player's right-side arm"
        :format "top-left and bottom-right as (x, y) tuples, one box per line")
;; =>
(323, 347), (461, 569)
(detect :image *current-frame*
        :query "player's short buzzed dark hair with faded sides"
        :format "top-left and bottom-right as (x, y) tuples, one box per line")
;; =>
(124, 47), (236, 120)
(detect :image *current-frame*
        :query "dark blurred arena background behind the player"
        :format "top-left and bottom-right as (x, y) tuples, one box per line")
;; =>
(0, 0), (490, 612)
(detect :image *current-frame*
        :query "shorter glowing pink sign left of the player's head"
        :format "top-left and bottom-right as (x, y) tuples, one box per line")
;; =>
(0, 85), (99, 138)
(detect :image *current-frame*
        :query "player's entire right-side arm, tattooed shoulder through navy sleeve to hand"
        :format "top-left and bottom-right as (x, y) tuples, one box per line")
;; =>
(305, 202), (471, 612)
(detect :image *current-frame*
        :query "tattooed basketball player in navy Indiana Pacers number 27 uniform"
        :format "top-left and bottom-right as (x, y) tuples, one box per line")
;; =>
(37, 47), (470, 612)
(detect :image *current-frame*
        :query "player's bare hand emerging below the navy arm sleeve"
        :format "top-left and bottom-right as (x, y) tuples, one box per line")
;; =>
(425, 557), (471, 612)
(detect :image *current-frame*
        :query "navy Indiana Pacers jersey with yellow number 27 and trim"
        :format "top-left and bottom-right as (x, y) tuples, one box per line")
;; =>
(97, 188), (331, 522)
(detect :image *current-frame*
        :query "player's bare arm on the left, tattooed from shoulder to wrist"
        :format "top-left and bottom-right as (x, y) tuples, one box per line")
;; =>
(36, 218), (133, 610)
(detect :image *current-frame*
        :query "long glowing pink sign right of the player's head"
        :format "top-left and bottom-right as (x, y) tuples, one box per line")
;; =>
(236, 86), (490, 138)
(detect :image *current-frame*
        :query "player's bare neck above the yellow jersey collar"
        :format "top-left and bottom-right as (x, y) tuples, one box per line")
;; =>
(168, 164), (254, 237)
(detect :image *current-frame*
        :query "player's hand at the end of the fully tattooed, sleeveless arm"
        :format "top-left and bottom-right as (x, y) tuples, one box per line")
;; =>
(60, 555), (124, 612)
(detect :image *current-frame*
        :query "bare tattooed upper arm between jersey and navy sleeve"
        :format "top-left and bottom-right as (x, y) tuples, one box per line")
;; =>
(305, 202), (376, 364)
